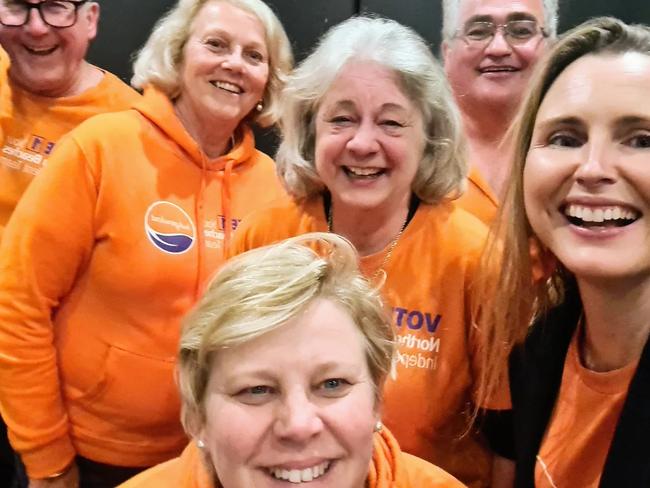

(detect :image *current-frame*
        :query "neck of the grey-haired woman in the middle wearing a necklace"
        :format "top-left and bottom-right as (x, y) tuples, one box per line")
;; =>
(330, 195), (410, 256)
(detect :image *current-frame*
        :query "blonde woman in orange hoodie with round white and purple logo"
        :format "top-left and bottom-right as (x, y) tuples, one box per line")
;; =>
(0, 0), (291, 488)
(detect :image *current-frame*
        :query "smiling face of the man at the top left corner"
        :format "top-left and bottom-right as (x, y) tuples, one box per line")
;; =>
(0, 1), (99, 97)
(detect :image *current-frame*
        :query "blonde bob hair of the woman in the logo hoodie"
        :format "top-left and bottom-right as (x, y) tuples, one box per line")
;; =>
(131, 0), (293, 127)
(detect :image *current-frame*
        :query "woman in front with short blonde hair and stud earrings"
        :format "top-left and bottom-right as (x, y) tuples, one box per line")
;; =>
(122, 233), (463, 488)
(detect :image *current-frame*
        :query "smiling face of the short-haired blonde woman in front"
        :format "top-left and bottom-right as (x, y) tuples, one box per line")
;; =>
(199, 299), (378, 488)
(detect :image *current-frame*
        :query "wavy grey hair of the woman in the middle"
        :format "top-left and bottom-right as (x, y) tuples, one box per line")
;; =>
(276, 17), (467, 203)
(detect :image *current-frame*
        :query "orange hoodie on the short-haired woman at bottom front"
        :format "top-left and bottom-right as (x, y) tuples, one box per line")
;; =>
(119, 428), (465, 488)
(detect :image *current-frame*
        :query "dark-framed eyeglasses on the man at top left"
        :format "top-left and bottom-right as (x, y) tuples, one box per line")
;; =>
(0, 0), (89, 27)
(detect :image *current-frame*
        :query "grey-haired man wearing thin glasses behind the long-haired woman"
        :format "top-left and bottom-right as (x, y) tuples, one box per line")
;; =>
(442, 0), (558, 222)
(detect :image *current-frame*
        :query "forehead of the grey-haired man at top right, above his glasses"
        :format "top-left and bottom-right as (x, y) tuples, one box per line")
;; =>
(458, 0), (544, 26)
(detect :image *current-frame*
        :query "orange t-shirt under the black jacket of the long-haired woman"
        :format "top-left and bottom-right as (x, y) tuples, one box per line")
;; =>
(535, 332), (637, 488)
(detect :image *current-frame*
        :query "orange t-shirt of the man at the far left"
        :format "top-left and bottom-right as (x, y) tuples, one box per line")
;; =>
(0, 67), (140, 238)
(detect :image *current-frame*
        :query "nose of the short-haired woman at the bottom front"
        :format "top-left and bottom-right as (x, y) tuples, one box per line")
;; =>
(273, 390), (323, 444)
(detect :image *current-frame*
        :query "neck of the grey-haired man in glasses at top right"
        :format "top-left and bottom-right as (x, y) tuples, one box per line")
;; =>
(463, 107), (512, 196)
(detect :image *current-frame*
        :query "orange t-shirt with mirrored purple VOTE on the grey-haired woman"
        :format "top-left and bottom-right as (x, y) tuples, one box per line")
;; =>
(231, 198), (510, 486)
